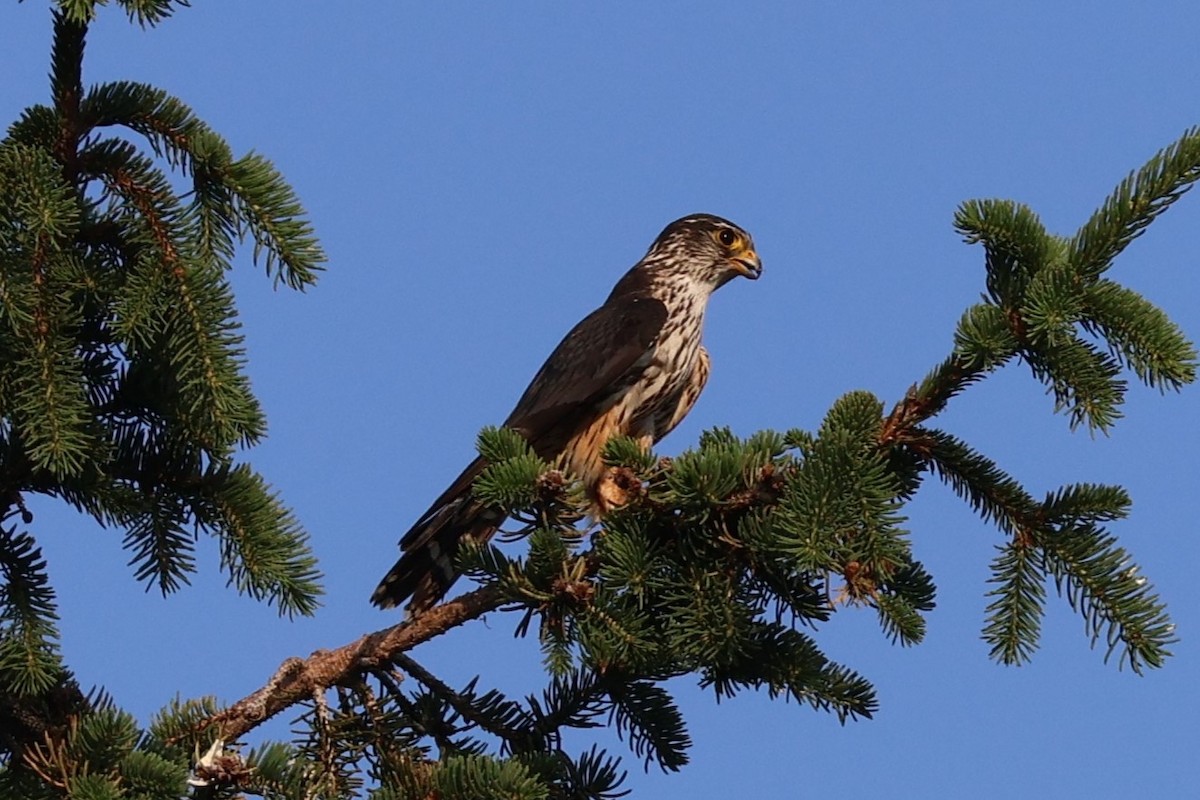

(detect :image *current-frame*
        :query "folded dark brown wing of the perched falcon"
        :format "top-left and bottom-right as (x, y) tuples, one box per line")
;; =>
(504, 295), (667, 443)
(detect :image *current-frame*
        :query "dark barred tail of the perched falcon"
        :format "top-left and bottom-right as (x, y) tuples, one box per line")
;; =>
(371, 458), (504, 618)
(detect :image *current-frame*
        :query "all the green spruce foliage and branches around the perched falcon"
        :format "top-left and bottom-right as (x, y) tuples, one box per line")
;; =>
(0, 0), (1200, 800)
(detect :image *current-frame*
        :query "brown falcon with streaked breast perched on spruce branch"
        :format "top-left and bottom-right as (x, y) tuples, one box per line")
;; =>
(371, 213), (762, 618)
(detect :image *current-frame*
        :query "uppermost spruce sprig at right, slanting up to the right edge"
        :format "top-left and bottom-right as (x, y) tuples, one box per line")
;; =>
(1068, 127), (1200, 282)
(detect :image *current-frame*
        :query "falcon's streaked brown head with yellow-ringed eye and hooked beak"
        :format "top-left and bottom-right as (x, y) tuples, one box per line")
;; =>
(643, 213), (762, 290)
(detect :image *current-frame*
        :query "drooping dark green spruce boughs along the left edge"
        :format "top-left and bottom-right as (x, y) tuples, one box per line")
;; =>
(0, 0), (324, 796)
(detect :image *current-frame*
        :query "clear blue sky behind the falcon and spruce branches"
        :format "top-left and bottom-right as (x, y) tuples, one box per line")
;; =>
(0, 0), (1200, 799)
